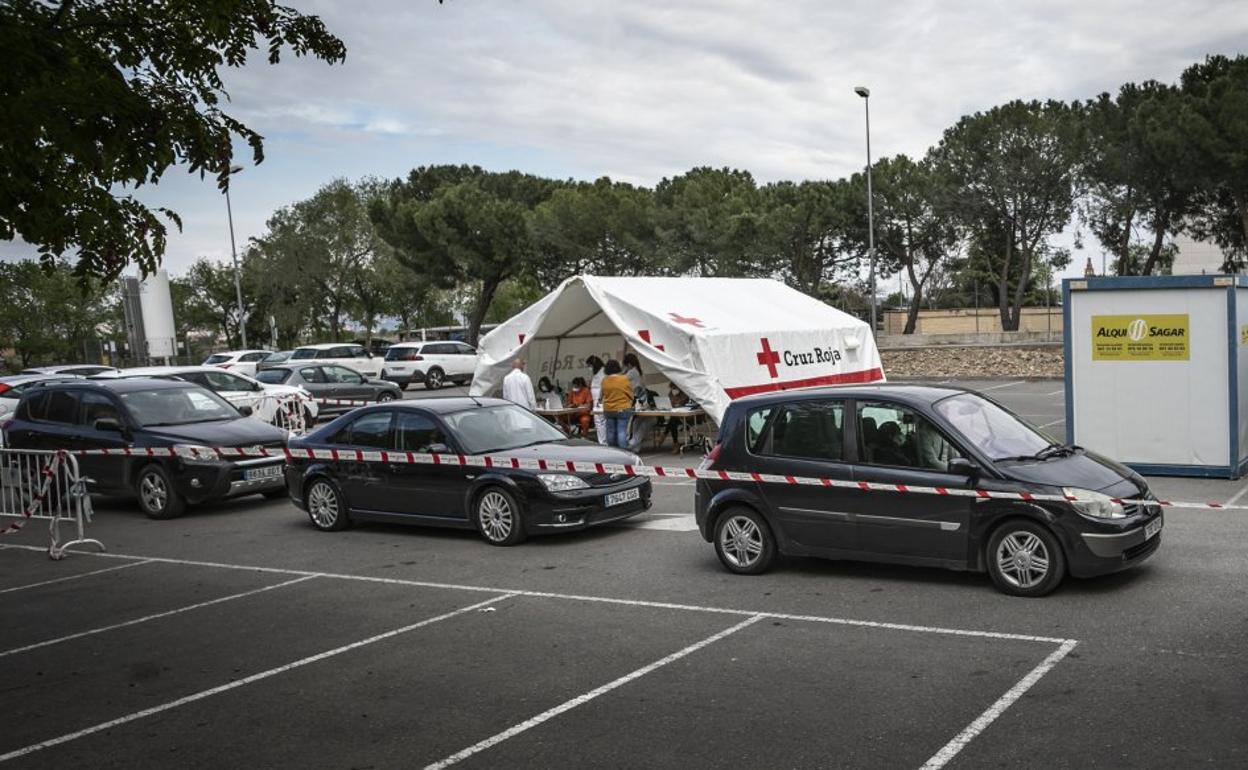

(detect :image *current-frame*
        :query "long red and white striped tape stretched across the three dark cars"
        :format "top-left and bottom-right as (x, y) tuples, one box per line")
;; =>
(65, 447), (1248, 510)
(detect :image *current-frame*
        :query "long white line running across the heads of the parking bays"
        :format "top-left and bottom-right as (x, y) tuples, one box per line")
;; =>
(0, 545), (1070, 644)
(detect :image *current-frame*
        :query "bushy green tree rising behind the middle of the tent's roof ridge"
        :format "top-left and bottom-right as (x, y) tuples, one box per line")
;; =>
(654, 166), (761, 277)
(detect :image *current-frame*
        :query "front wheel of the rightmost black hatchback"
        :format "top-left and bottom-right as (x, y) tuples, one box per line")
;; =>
(985, 519), (1066, 597)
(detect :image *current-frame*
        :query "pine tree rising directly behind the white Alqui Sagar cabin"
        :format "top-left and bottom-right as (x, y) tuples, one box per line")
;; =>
(1077, 81), (1194, 276)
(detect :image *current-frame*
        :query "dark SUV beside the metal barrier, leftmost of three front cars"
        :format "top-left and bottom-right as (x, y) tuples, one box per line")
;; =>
(5, 378), (286, 519)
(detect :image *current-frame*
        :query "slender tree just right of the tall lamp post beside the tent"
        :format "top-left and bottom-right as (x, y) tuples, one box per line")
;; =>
(858, 155), (965, 334)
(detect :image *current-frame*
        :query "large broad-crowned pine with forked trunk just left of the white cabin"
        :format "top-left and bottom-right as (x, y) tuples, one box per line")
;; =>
(932, 101), (1077, 331)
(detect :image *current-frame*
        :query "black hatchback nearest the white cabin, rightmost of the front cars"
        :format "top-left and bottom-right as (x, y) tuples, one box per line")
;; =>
(695, 384), (1162, 597)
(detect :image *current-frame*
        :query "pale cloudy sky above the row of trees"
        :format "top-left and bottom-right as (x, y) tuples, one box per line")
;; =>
(4, 0), (1248, 272)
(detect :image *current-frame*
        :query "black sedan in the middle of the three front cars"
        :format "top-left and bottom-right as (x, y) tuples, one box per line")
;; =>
(286, 398), (650, 545)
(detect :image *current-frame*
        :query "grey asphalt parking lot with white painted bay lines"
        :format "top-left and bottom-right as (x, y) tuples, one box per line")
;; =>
(0, 381), (1248, 768)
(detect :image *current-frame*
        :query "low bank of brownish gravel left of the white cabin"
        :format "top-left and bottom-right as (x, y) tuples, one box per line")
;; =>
(880, 346), (1065, 379)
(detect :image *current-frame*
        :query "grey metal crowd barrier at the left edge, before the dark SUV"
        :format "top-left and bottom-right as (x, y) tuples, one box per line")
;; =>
(0, 448), (104, 559)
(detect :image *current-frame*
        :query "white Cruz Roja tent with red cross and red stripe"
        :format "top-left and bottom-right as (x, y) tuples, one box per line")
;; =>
(472, 276), (884, 423)
